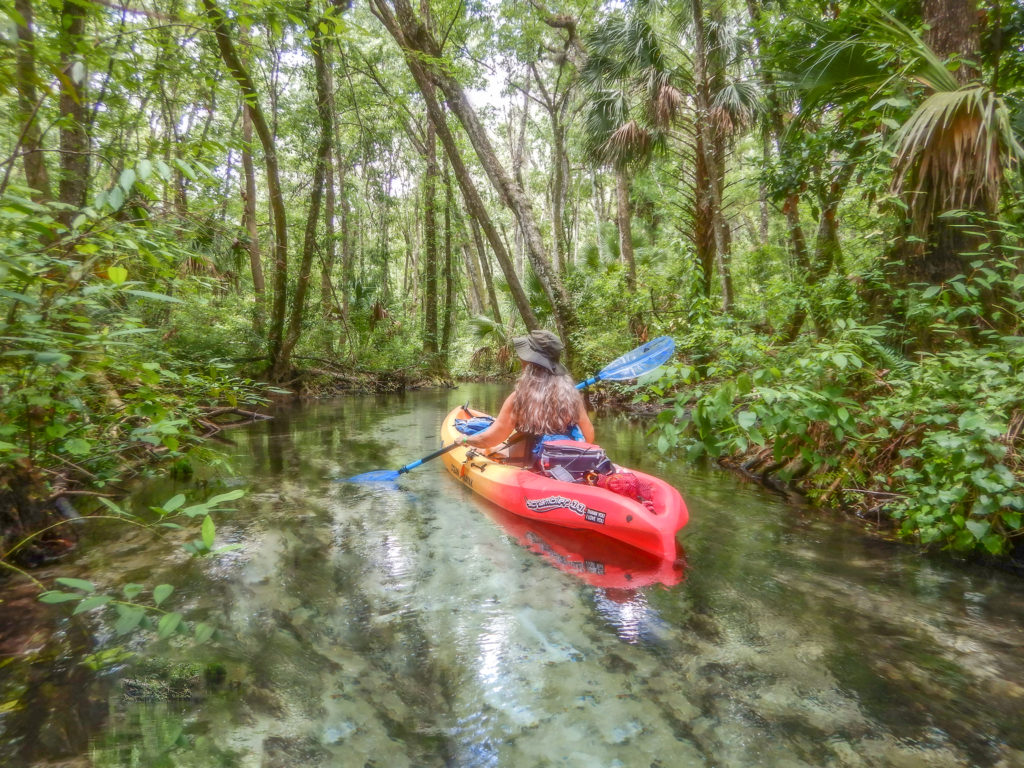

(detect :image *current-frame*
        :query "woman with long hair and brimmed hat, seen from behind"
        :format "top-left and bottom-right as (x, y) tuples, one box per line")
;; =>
(462, 331), (594, 449)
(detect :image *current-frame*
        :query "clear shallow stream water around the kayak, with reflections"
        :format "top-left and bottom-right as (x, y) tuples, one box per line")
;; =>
(0, 385), (1024, 768)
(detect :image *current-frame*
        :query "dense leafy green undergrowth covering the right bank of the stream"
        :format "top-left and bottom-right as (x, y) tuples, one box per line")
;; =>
(645, 231), (1024, 556)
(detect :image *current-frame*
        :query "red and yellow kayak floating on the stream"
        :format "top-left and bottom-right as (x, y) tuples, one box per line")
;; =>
(441, 406), (689, 558)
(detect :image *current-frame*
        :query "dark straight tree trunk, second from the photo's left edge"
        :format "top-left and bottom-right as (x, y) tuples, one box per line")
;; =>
(58, 0), (89, 219)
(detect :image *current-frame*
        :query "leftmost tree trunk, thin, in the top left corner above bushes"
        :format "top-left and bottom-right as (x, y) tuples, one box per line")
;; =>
(14, 0), (53, 202)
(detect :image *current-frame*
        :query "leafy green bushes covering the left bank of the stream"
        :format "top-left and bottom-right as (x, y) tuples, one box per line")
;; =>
(0, 186), (274, 486)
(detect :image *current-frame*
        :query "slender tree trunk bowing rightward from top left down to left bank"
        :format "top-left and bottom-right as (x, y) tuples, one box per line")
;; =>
(203, 0), (288, 371)
